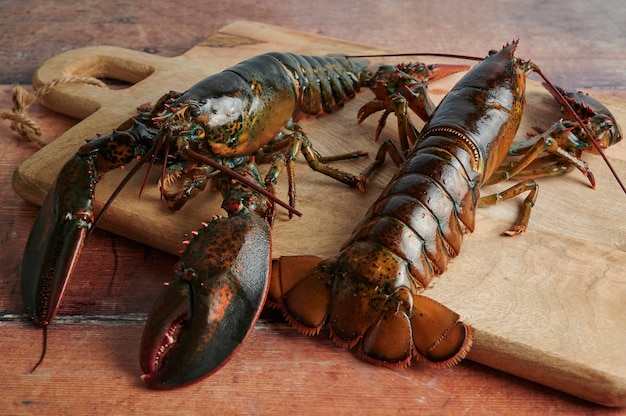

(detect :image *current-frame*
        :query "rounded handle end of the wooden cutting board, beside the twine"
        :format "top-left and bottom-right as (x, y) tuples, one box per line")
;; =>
(33, 46), (172, 120)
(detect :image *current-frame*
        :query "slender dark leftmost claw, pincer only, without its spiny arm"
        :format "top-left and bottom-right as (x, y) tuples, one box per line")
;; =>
(21, 155), (96, 327)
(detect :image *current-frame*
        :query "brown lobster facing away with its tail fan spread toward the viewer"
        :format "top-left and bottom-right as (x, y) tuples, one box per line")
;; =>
(269, 41), (621, 367)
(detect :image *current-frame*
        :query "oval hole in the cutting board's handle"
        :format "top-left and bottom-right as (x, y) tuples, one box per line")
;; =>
(66, 55), (154, 90)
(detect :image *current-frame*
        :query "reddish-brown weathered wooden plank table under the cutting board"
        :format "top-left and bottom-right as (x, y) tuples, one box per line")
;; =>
(0, 1), (626, 414)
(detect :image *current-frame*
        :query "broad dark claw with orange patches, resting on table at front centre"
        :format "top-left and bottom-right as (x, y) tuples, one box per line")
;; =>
(140, 210), (271, 389)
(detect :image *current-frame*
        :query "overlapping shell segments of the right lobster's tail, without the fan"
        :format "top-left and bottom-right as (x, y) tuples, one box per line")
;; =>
(340, 141), (477, 288)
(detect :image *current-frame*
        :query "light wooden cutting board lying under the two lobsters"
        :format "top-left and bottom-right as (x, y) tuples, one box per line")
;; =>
(14, 22), (626, 406)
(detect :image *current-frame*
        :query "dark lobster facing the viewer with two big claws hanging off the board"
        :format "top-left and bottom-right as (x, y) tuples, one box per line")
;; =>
(21, 53), (464, 388)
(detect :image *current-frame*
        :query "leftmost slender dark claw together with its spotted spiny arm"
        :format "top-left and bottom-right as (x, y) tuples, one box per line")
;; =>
(22, 114), (156, 327)
